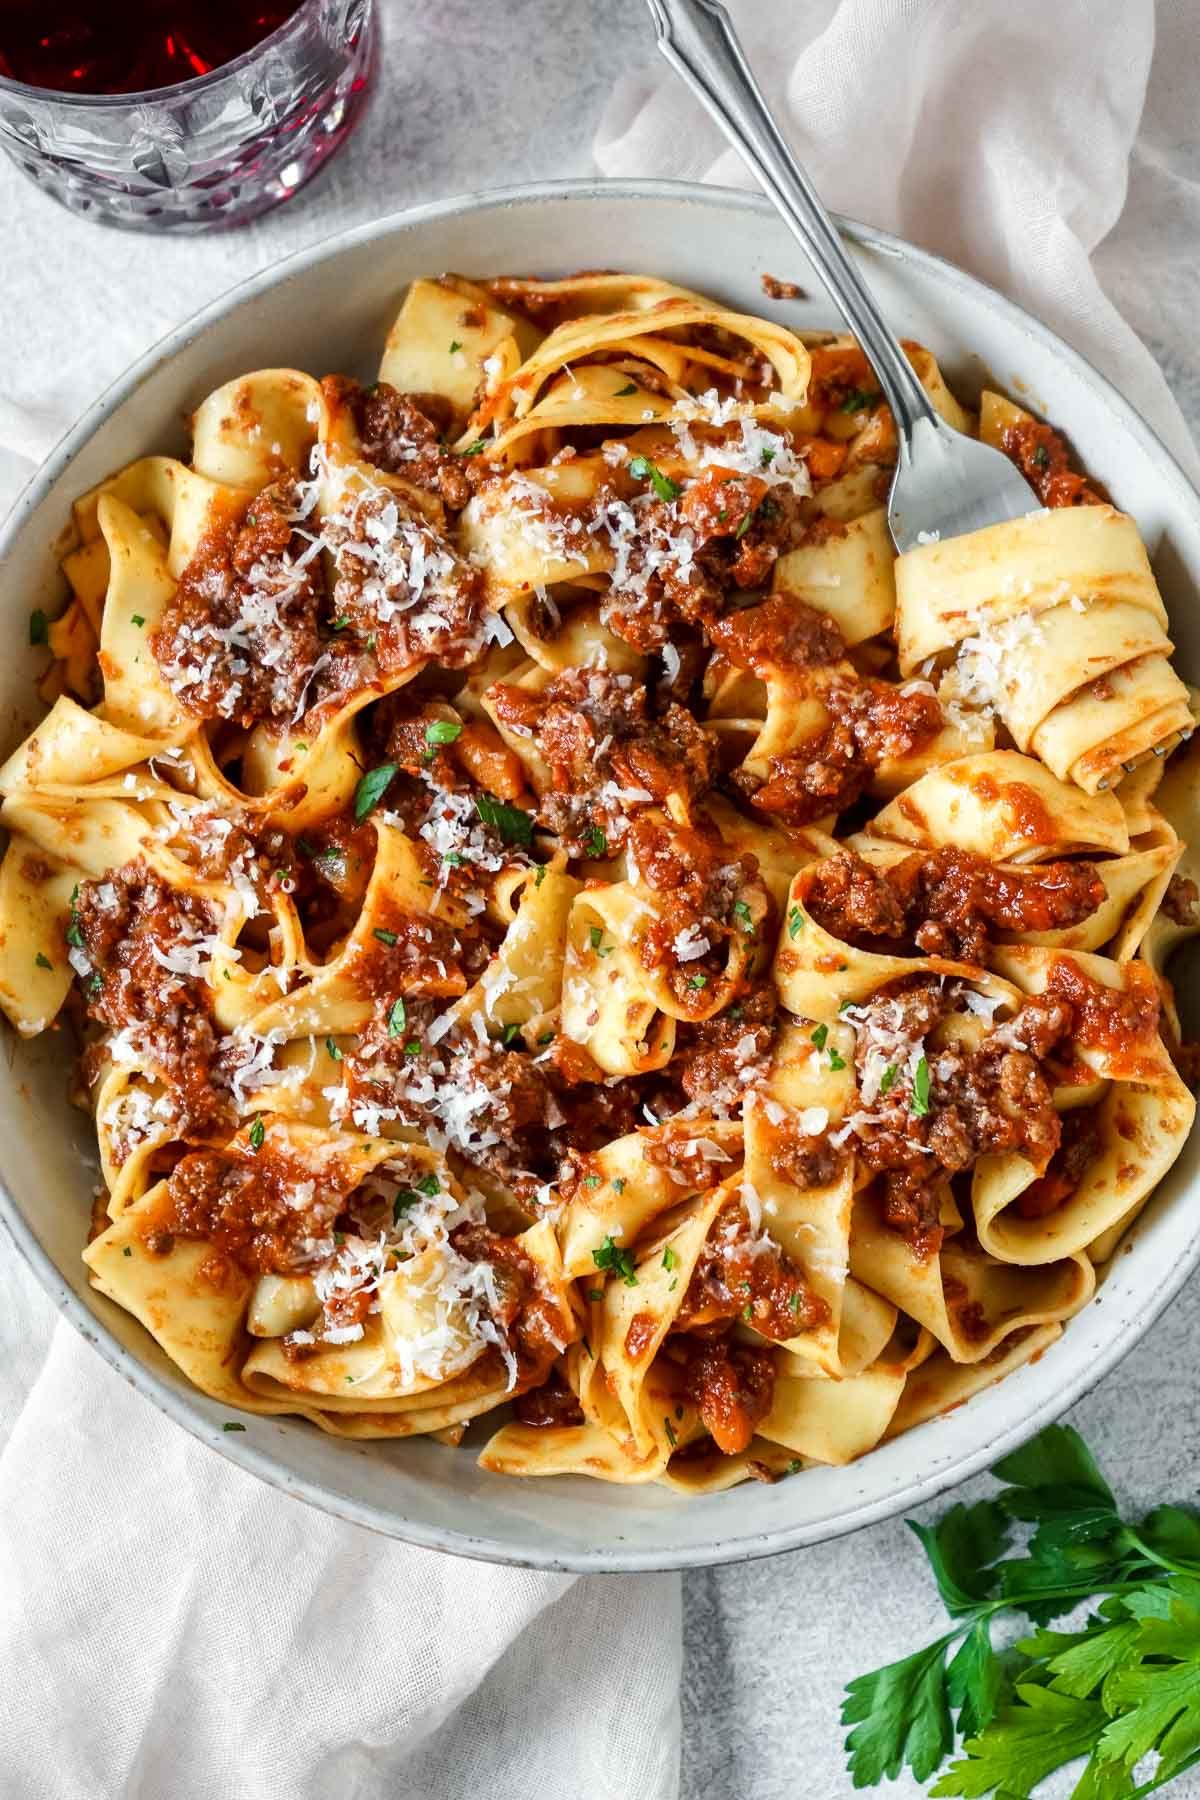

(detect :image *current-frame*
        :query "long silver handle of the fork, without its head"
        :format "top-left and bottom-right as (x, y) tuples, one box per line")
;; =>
(648, 0), (939, 442)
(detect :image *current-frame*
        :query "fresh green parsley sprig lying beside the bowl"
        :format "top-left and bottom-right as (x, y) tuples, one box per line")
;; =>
(842, 1426), (1200, 1800)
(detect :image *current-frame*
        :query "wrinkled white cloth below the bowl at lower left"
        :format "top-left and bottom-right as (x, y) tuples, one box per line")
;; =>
(0, 1325), (680, 1800)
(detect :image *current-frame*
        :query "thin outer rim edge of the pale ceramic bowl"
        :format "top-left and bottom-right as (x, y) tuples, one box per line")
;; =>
(0, 176), (1200, 1573)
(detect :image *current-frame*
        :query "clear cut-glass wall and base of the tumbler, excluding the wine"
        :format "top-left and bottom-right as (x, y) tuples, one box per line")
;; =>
(0, 5), (376, 232)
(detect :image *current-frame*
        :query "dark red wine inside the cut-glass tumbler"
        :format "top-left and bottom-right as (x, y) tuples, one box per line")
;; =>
(0, 0), (300, 94)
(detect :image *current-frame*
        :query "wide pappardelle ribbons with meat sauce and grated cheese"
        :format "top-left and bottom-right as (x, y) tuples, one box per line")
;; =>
(0, 274), (1200, 1494)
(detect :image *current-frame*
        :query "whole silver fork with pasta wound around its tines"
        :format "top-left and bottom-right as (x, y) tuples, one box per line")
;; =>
(648, 0), (1042, 551)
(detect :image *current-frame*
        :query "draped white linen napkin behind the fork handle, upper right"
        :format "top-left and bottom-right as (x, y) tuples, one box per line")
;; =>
(596, 0), (1200, 479)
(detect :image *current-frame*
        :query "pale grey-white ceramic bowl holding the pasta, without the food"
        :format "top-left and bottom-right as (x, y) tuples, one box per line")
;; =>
(0, 182), (1200, 1570)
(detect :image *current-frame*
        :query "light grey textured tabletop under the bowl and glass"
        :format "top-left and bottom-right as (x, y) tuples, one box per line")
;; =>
(0, 0), (1200, 1800)
